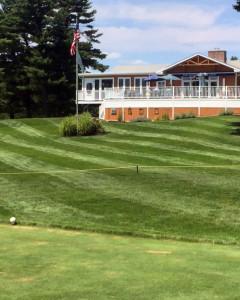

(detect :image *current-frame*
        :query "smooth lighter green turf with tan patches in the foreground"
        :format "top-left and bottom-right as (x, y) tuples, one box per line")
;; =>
(0, 226), (240, 300)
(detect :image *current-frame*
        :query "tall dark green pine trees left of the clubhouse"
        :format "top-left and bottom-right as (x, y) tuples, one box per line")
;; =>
(0, 0), (107, 118)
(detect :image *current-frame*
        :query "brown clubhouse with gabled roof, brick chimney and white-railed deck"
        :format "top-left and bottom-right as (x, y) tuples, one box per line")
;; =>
(78, 49), (240, 122)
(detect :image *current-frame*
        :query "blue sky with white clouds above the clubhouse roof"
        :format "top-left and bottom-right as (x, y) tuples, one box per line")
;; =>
(91, 0), (240, 69)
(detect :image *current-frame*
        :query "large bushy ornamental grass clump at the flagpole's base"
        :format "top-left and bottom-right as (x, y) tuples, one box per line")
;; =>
(60, 112), (104, 136)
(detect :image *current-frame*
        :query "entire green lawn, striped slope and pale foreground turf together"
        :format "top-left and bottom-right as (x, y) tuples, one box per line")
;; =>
(0, 116), (240, 300)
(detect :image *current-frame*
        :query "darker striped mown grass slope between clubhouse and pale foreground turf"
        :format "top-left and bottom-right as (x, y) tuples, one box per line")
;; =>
(0, 117), (240, 243)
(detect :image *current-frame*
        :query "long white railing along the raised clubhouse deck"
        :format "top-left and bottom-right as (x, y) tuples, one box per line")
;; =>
(79, 86), (240, 101)
